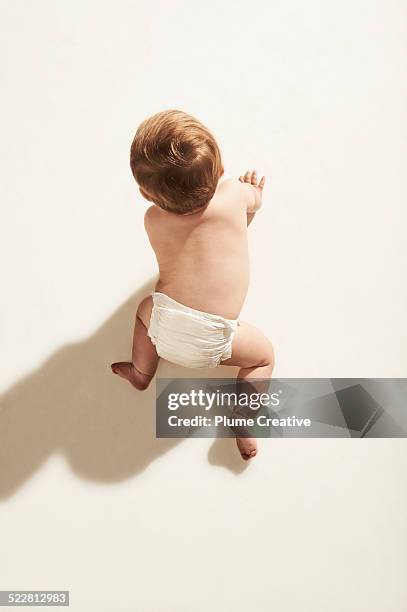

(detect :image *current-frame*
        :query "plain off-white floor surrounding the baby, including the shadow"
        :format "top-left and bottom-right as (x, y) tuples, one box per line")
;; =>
(0, 0), (407, 612)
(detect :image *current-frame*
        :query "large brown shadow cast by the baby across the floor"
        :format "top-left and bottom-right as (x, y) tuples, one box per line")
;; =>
(0, 282), (245, 499)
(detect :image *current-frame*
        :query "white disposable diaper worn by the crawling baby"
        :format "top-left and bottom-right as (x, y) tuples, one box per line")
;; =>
(148, 292), (237, 368)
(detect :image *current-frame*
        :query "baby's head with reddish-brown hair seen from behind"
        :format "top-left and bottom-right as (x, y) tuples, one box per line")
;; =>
(130, 110), (223, 215)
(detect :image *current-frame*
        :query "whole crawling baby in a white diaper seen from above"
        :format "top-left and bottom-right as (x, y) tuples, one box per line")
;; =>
(111, 110), (274, 460)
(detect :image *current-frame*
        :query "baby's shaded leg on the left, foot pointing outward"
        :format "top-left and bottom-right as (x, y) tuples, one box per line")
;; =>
(111, 296), (159, 391)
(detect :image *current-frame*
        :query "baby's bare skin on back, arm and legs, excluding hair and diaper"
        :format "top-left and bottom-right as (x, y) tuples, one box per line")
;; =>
(112, 171), (274, 460)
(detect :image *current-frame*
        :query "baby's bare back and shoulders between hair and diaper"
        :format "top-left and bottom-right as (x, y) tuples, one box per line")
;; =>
(145, 180), (249, 319)
